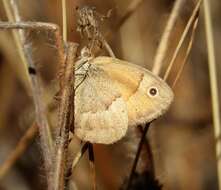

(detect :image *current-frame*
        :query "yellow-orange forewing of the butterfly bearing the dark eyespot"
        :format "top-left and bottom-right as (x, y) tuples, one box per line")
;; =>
(91, 57), (173, 125)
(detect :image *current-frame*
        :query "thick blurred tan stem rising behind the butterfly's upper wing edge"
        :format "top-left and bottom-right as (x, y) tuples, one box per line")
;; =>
(152, 0), (185, 75)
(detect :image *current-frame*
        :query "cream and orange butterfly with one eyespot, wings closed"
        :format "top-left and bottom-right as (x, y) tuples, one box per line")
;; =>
(74, 56), (174, 144)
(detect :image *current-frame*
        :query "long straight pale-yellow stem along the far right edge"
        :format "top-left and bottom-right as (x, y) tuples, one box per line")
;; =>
(203, 0), (221, 189)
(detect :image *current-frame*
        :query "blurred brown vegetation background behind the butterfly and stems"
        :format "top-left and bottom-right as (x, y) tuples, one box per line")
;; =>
(0, 0), (221, 190)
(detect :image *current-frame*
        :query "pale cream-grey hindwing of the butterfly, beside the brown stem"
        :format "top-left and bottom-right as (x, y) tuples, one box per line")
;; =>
(75, 66), (128, 144)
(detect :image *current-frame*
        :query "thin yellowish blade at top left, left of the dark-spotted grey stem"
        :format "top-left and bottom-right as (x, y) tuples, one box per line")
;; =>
(3, 0), (32, 93)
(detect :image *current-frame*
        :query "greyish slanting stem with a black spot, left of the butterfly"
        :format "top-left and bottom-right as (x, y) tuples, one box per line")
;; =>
(1, 0), (53, 180)
